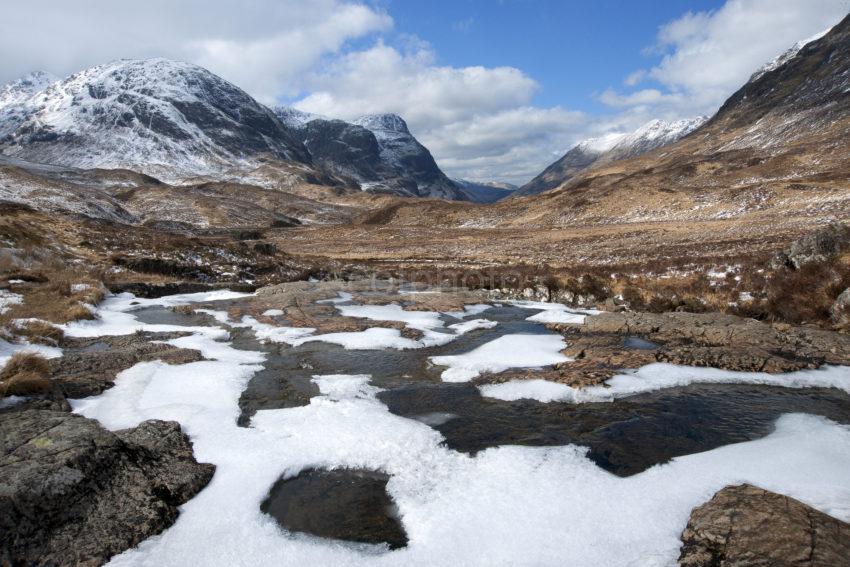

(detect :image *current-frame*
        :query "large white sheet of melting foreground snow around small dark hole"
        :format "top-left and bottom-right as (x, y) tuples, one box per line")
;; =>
(59, 290), (850, 567)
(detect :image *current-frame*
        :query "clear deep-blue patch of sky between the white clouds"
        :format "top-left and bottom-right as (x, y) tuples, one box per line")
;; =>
(383, 0), (723, 112)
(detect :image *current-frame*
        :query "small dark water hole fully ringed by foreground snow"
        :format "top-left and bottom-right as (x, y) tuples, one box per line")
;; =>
(260, 469), (407, 549)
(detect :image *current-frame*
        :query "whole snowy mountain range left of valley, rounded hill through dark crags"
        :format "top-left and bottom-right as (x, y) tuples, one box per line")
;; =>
(0, 59), (468, 200)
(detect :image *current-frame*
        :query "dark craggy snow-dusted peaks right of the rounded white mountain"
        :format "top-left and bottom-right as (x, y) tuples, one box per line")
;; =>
(274, 107), (469, 200)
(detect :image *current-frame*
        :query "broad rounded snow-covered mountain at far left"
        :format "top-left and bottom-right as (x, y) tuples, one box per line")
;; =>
(0, 59), (310, 180)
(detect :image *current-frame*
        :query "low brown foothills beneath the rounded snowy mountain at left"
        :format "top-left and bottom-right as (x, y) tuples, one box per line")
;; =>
(0, 155), (372, 231)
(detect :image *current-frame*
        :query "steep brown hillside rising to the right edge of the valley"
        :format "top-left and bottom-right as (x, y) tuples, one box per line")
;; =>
(494, 12), (850, 226)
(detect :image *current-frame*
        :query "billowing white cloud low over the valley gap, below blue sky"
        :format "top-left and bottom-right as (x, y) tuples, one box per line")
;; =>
(296, 41), (587, 182)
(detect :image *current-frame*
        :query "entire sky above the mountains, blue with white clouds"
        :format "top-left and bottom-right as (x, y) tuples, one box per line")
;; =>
(0, 0), (850, 184)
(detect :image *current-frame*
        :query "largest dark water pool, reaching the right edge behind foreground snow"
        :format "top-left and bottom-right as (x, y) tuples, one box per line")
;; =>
(379, 384), (850, 476)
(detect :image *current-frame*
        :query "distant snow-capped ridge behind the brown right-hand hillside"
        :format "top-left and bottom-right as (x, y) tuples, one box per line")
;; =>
(514, 116), (708, 197)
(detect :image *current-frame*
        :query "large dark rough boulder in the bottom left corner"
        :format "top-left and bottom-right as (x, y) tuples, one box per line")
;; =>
(0, 410), (215, 565)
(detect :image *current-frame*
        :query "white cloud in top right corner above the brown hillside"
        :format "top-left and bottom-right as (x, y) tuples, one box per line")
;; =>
(600, 0), (850, 116)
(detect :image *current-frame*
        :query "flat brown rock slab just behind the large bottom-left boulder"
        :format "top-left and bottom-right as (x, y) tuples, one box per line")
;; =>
(51, 333), (203, 398)
